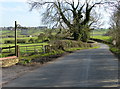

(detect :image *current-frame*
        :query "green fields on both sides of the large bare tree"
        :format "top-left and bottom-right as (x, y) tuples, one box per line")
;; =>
(0, 29), (110, 57)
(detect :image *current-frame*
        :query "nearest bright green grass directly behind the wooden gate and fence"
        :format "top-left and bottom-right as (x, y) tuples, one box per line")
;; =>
(1, 43), (48, 57)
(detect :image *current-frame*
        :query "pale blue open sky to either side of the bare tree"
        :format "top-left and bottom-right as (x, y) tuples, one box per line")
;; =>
(0, 0), (109, 28)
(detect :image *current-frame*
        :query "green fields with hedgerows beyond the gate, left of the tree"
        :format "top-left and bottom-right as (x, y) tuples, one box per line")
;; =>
(0, 28), (62, 57)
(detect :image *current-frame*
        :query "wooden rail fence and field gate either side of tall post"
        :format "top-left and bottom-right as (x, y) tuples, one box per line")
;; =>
(0, 45), (49, 57)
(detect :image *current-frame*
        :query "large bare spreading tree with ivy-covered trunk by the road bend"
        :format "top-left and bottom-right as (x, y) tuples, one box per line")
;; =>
(29, 0), (108, 41)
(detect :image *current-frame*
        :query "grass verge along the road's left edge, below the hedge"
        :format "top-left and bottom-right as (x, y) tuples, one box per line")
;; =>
(19, 46), (99, 65)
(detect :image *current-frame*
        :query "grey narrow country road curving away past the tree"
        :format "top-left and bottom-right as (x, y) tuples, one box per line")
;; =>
(3, 44), (118, 87)
